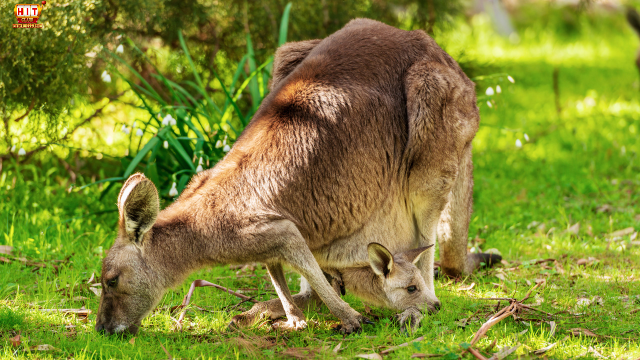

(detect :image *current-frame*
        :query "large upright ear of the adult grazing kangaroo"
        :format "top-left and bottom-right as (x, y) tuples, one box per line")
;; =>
(118, 174), (160, 245)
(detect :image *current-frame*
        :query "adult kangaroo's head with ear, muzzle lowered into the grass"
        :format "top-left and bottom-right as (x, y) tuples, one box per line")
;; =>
(96, 174), (164, 334)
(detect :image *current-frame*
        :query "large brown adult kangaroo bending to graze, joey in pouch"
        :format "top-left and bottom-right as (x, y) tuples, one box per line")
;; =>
(96, 19), (500, 333)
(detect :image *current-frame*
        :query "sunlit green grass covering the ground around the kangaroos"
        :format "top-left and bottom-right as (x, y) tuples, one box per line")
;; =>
(0, 8), (640, 359)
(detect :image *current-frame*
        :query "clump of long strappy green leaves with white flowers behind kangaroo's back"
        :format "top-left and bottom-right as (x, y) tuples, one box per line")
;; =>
(88, 4), (291, 197)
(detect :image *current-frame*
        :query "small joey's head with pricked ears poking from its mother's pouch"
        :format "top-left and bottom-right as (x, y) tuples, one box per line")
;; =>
(367, 243), (439, 311)
